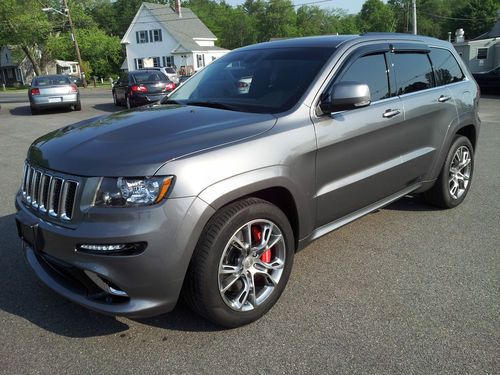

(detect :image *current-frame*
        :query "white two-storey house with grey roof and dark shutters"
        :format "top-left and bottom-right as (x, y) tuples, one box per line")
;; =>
(122, 1), (229, 72)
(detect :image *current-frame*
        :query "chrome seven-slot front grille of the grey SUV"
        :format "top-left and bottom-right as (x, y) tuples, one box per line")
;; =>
(21, 163), (78, 222)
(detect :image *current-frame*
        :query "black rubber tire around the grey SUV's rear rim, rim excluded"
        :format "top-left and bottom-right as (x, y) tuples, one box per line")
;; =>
(423, 134), (474, 208)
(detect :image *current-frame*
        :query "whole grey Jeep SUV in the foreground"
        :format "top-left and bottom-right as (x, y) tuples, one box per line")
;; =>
(16, 34), (480, 327)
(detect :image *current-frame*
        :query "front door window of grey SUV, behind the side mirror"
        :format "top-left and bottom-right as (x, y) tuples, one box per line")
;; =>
(337, 54), (390, 102)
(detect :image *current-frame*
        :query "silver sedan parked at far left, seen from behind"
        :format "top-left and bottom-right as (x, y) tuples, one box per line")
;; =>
(28, 75), (82, 115)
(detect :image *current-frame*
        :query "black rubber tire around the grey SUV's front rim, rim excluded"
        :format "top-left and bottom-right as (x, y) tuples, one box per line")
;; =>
(183, 198), (295, 328)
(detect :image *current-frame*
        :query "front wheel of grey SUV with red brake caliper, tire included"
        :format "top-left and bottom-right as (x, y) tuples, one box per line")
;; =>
(183, 198), (295, 328)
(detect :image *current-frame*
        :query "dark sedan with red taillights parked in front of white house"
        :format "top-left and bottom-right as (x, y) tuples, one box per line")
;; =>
(112, 70), (176, 108)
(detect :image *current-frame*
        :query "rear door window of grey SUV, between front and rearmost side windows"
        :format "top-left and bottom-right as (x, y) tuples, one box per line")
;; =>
(392, 53), (434, 95)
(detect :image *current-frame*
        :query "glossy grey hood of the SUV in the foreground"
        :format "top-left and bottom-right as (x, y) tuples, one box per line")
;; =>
(28, 105), (276, 177)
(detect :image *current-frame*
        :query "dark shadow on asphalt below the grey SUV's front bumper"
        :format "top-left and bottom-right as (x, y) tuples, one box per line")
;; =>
(0, 214), (220, 337)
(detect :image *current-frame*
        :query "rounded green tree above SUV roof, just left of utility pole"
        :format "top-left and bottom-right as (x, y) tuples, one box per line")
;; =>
(359, 0), (396, 32)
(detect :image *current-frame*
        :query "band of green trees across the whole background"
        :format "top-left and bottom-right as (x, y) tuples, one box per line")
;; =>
(0, 0), (500, 77)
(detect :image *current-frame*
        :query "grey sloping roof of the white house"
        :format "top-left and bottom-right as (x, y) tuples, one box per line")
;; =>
(122, 3), (225, 52)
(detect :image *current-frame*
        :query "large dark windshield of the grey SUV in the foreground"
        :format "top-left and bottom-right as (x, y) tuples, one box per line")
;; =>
(164, 47), (334, 113)
